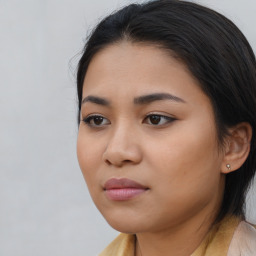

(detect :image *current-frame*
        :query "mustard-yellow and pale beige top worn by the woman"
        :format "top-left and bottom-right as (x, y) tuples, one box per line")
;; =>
(99, 217), (256, 256)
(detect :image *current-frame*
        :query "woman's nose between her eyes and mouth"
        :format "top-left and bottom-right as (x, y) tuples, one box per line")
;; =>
(103, 127), (142, 167)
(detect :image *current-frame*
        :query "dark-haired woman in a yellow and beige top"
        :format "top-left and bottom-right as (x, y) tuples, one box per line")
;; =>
(77, 0), (256, 256)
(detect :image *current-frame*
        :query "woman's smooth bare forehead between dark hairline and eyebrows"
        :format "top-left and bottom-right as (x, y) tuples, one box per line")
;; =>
(83, 41), (208, 106)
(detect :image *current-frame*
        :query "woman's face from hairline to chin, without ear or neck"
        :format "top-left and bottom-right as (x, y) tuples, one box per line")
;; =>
(77, 42), (224, 233)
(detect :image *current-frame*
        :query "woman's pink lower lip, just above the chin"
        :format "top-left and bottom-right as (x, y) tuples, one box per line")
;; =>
(105, 188), (147, 201)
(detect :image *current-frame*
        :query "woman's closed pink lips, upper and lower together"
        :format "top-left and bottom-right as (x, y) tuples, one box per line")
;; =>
(104, 178), (148, 201)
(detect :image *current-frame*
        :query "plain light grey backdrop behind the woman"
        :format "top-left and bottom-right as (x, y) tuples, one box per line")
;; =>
(0, 0), (256, 256)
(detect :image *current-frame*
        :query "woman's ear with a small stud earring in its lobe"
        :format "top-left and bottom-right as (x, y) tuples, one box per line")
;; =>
(221, 122), (252, 174)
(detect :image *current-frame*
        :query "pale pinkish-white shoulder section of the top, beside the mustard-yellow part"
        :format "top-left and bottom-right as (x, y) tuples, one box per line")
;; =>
(228, 221), (256, 256)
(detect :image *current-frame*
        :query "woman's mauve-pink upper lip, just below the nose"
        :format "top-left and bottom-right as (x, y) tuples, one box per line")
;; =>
(104, 178), (147, 190)
